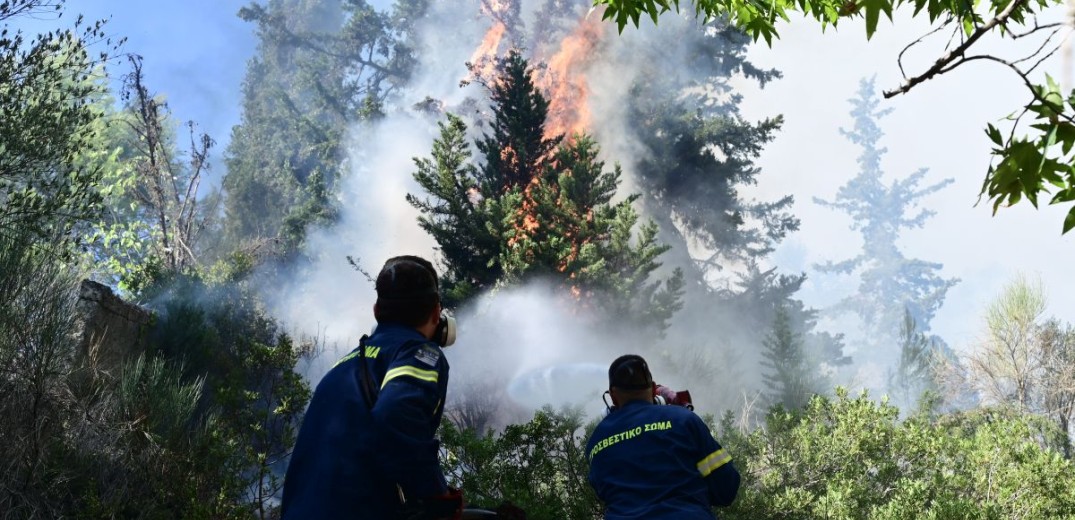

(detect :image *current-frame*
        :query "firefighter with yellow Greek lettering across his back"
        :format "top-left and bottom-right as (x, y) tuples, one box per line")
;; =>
(586, 355), (740, 520)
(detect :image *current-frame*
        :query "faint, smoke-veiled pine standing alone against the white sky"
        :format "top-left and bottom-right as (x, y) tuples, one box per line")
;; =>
(815, 80), (959, 341)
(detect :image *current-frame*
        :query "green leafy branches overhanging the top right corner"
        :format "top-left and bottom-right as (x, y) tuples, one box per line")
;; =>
(593, 0), (1075, 233)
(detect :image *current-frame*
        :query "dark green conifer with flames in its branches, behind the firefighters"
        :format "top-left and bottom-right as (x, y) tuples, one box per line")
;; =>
(407, 50), (683, 333)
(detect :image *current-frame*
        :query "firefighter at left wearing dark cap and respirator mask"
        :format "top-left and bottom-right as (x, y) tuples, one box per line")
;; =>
(281, 256), (463, 520)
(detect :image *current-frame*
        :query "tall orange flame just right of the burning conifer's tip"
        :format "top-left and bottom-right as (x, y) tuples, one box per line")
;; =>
(538, 17), (604, 138)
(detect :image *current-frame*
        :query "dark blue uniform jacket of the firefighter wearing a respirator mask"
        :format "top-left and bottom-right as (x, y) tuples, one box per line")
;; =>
(282, 324), (448, 520)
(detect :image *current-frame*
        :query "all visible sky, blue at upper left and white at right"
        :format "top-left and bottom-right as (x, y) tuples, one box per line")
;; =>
(10, 0), (1075, 348)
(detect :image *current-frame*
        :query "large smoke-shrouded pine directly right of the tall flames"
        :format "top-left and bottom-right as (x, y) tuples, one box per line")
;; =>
(630, 24), (799, 279)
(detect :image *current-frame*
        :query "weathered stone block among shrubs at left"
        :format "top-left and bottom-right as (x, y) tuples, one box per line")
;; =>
(77, 279), (153, 370)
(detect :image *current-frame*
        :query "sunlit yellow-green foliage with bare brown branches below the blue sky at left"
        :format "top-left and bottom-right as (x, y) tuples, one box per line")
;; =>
(78, 57), (215, 294)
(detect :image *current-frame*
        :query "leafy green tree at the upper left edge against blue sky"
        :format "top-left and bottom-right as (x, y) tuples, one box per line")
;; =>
(0, 0), (112, 252)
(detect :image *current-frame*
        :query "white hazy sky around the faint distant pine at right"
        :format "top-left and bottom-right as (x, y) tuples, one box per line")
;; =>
(743, 13), (1075, 348)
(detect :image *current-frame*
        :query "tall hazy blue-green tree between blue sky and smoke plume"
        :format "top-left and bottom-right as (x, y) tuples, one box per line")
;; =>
(224, 0), (427, 254)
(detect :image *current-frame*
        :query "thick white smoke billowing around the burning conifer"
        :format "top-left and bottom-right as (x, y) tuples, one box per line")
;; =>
(262, 1), (782, 424)
